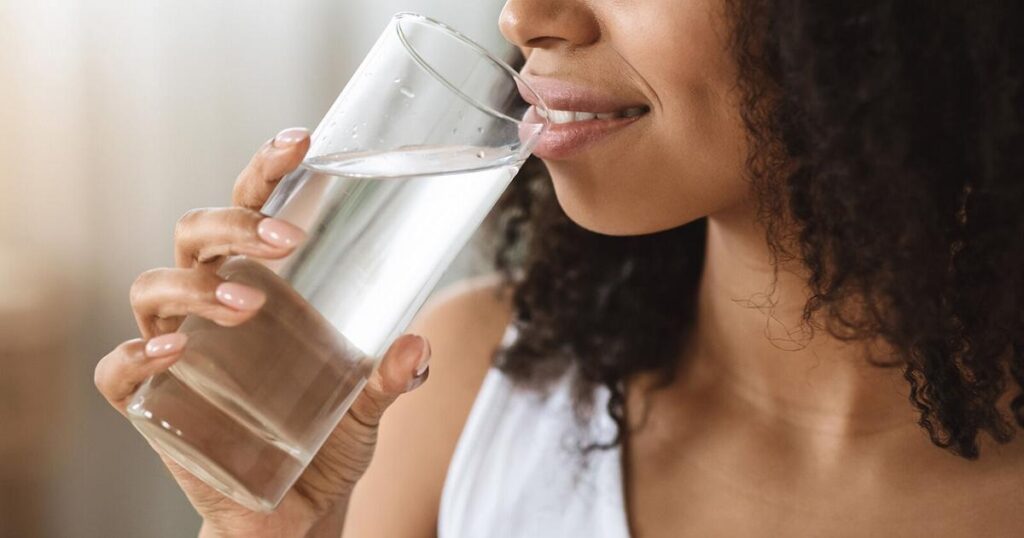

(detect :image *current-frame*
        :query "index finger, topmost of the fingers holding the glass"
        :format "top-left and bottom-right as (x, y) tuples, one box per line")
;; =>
(232, 127), (309, 209)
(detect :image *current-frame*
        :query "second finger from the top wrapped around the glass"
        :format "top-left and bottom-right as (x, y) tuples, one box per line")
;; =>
(174, 207), (305, 268)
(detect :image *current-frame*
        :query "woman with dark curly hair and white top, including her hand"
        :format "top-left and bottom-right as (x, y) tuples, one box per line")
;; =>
(96, 0), (1024, 537)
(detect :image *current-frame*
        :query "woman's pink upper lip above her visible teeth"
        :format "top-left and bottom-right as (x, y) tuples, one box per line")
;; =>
(516, 75), (649, 114)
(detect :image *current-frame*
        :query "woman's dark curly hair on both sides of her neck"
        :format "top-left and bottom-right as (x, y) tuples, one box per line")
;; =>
(488, 0), (1024, 459)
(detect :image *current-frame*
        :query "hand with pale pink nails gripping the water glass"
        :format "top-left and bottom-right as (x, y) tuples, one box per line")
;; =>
(95, 129), (430, 537)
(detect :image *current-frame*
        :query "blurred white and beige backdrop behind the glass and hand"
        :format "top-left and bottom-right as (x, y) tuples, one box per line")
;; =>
(0, 0), (508, 538)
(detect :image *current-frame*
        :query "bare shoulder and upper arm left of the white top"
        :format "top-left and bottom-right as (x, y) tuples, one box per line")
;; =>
(345, 274), (512, 538)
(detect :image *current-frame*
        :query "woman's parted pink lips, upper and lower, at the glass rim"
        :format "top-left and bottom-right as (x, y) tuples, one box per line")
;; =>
(517, 76), (650, 160)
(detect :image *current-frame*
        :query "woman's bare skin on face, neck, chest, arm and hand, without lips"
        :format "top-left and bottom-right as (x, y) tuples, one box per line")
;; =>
(96, 0), (1024, 537)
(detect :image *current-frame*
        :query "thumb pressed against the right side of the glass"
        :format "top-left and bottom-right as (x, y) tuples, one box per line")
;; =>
(348, 334), (430, 427)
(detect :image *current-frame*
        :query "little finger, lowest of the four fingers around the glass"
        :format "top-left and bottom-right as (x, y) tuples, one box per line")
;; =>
(93, 333), (188, 414)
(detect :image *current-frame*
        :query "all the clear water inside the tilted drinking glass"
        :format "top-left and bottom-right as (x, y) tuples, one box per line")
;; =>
(129, 148), (521, 511)
